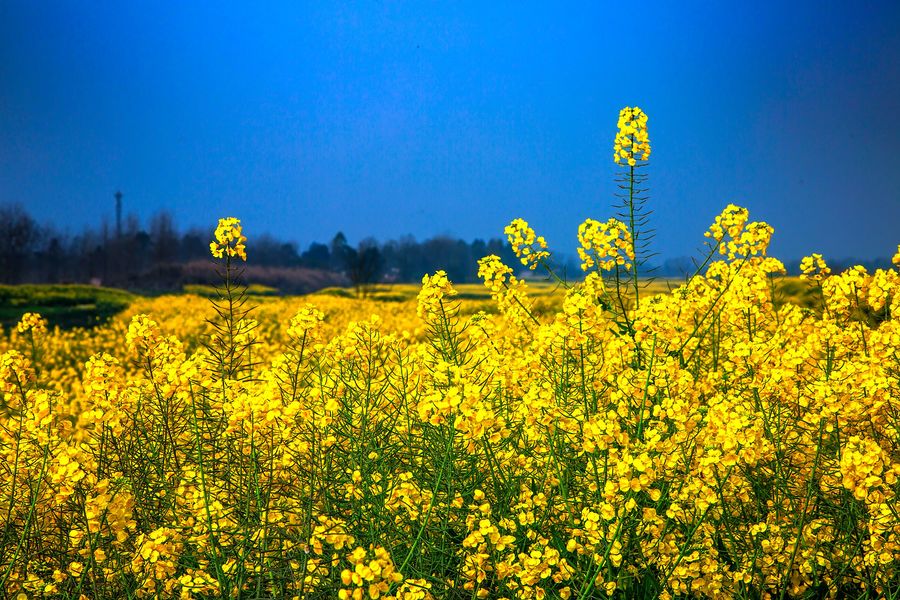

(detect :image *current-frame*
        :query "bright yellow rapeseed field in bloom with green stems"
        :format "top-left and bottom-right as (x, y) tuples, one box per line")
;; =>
(0, 108), (900, 599)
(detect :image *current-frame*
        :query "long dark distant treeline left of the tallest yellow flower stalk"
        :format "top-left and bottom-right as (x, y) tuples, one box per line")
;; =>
(0, 204), (517, 294)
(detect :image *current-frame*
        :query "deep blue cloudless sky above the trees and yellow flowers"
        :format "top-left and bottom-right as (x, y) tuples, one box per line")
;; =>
(0, 0), (900, 259)
